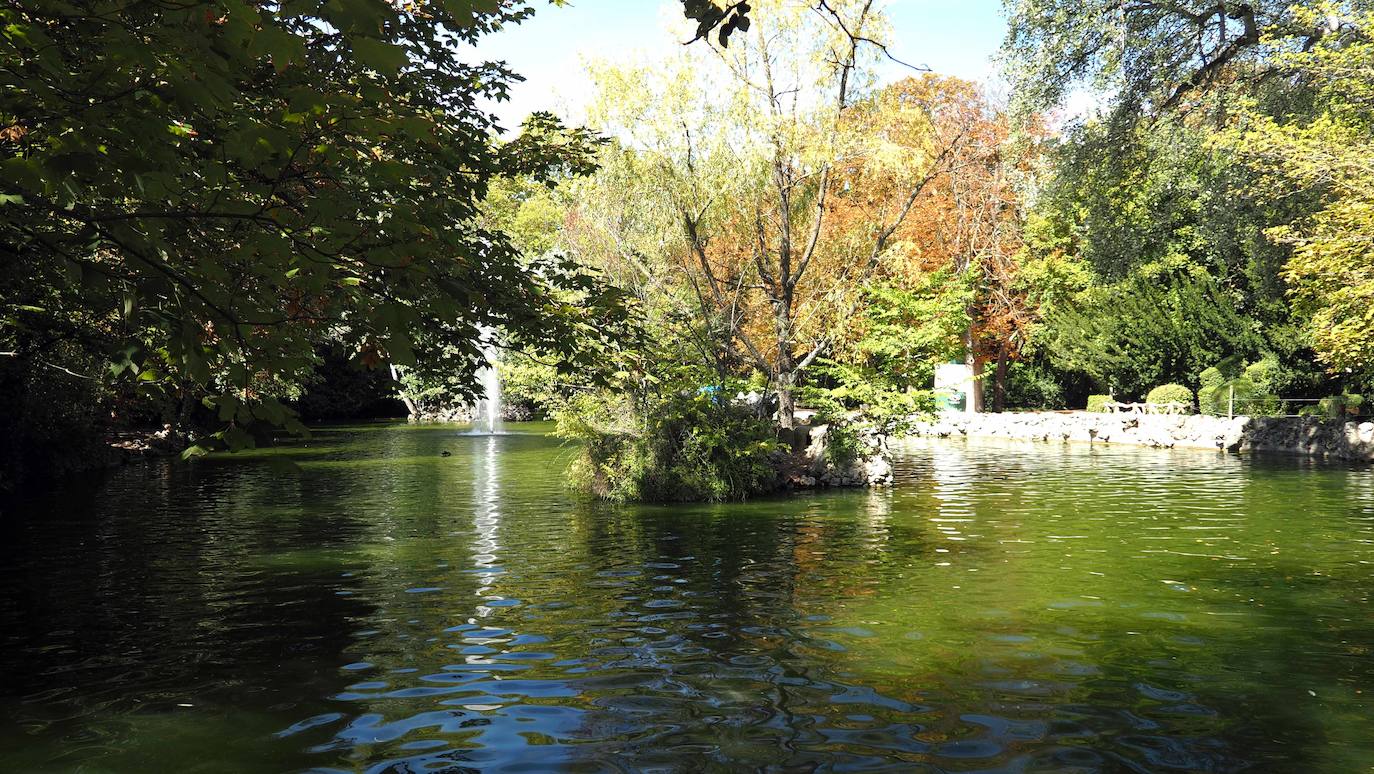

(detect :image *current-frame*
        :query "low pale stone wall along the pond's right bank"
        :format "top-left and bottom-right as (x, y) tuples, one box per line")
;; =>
(911, 411), (1374, 462)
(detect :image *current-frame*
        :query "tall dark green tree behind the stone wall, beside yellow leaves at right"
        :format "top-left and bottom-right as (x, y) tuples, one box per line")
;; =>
(1006, 0), (1367, 392)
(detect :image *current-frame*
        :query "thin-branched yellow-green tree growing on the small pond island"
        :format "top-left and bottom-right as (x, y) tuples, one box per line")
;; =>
(592, 0), (963, 428)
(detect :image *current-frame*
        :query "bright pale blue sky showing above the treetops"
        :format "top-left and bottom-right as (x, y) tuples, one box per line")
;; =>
(475, 0), (1006, 131)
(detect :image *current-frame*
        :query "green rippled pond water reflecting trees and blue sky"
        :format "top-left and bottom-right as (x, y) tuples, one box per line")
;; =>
(0, 425), (1374, 773)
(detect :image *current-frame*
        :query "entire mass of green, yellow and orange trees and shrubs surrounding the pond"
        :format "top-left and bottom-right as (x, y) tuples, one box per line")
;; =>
(0, 0), (1374, 499)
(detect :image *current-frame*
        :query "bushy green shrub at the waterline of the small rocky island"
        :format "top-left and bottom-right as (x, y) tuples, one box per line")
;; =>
(555, 390), (780, 502)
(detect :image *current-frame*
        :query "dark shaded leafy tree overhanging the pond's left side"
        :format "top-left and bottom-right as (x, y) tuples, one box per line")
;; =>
(0, 0), (629, 445)
